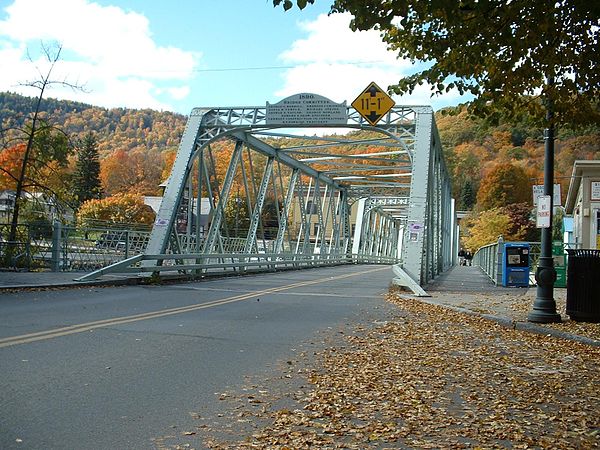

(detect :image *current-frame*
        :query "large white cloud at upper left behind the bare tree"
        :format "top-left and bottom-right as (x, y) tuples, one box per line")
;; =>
(0, 0), (201, 109)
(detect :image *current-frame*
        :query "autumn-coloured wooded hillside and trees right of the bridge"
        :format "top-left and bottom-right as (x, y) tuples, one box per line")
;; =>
(436, 109), (600, 210)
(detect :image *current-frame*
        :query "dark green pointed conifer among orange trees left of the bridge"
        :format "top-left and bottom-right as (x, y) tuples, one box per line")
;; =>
(73, 132), (102, 205)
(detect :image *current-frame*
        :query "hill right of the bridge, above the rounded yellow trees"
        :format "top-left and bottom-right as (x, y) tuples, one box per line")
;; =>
(436, 107), (600, 210)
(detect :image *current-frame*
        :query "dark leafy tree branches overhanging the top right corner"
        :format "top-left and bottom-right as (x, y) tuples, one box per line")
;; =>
(273, 0), (600, 124)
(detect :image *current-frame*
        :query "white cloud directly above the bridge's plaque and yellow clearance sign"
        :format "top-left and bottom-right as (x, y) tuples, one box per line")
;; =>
(275, 14), (465, 109)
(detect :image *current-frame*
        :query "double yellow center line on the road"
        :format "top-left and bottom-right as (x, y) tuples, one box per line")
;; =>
(0, 267), (389, 348)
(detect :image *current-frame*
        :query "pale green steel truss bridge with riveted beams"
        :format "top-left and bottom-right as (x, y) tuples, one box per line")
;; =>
(80, 94), (456, 285)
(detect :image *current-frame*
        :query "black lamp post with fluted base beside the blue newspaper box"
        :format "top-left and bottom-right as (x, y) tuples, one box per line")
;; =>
(527, 77), (561, 323)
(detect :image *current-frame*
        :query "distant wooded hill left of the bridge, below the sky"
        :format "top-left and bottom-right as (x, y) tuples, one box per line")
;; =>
(0, 92), (187, 156)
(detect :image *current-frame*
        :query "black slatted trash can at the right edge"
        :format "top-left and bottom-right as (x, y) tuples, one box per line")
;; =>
(567, 248), (600, 322)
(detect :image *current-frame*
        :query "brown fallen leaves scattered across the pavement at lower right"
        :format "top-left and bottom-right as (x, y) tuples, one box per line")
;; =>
(190, 294), (600, 449)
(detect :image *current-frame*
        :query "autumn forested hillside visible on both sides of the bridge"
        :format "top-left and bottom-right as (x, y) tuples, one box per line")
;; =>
(0, 93), (600, 210)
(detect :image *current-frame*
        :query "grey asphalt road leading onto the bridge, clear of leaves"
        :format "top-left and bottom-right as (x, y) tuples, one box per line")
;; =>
(0, 266), (393, 449)
